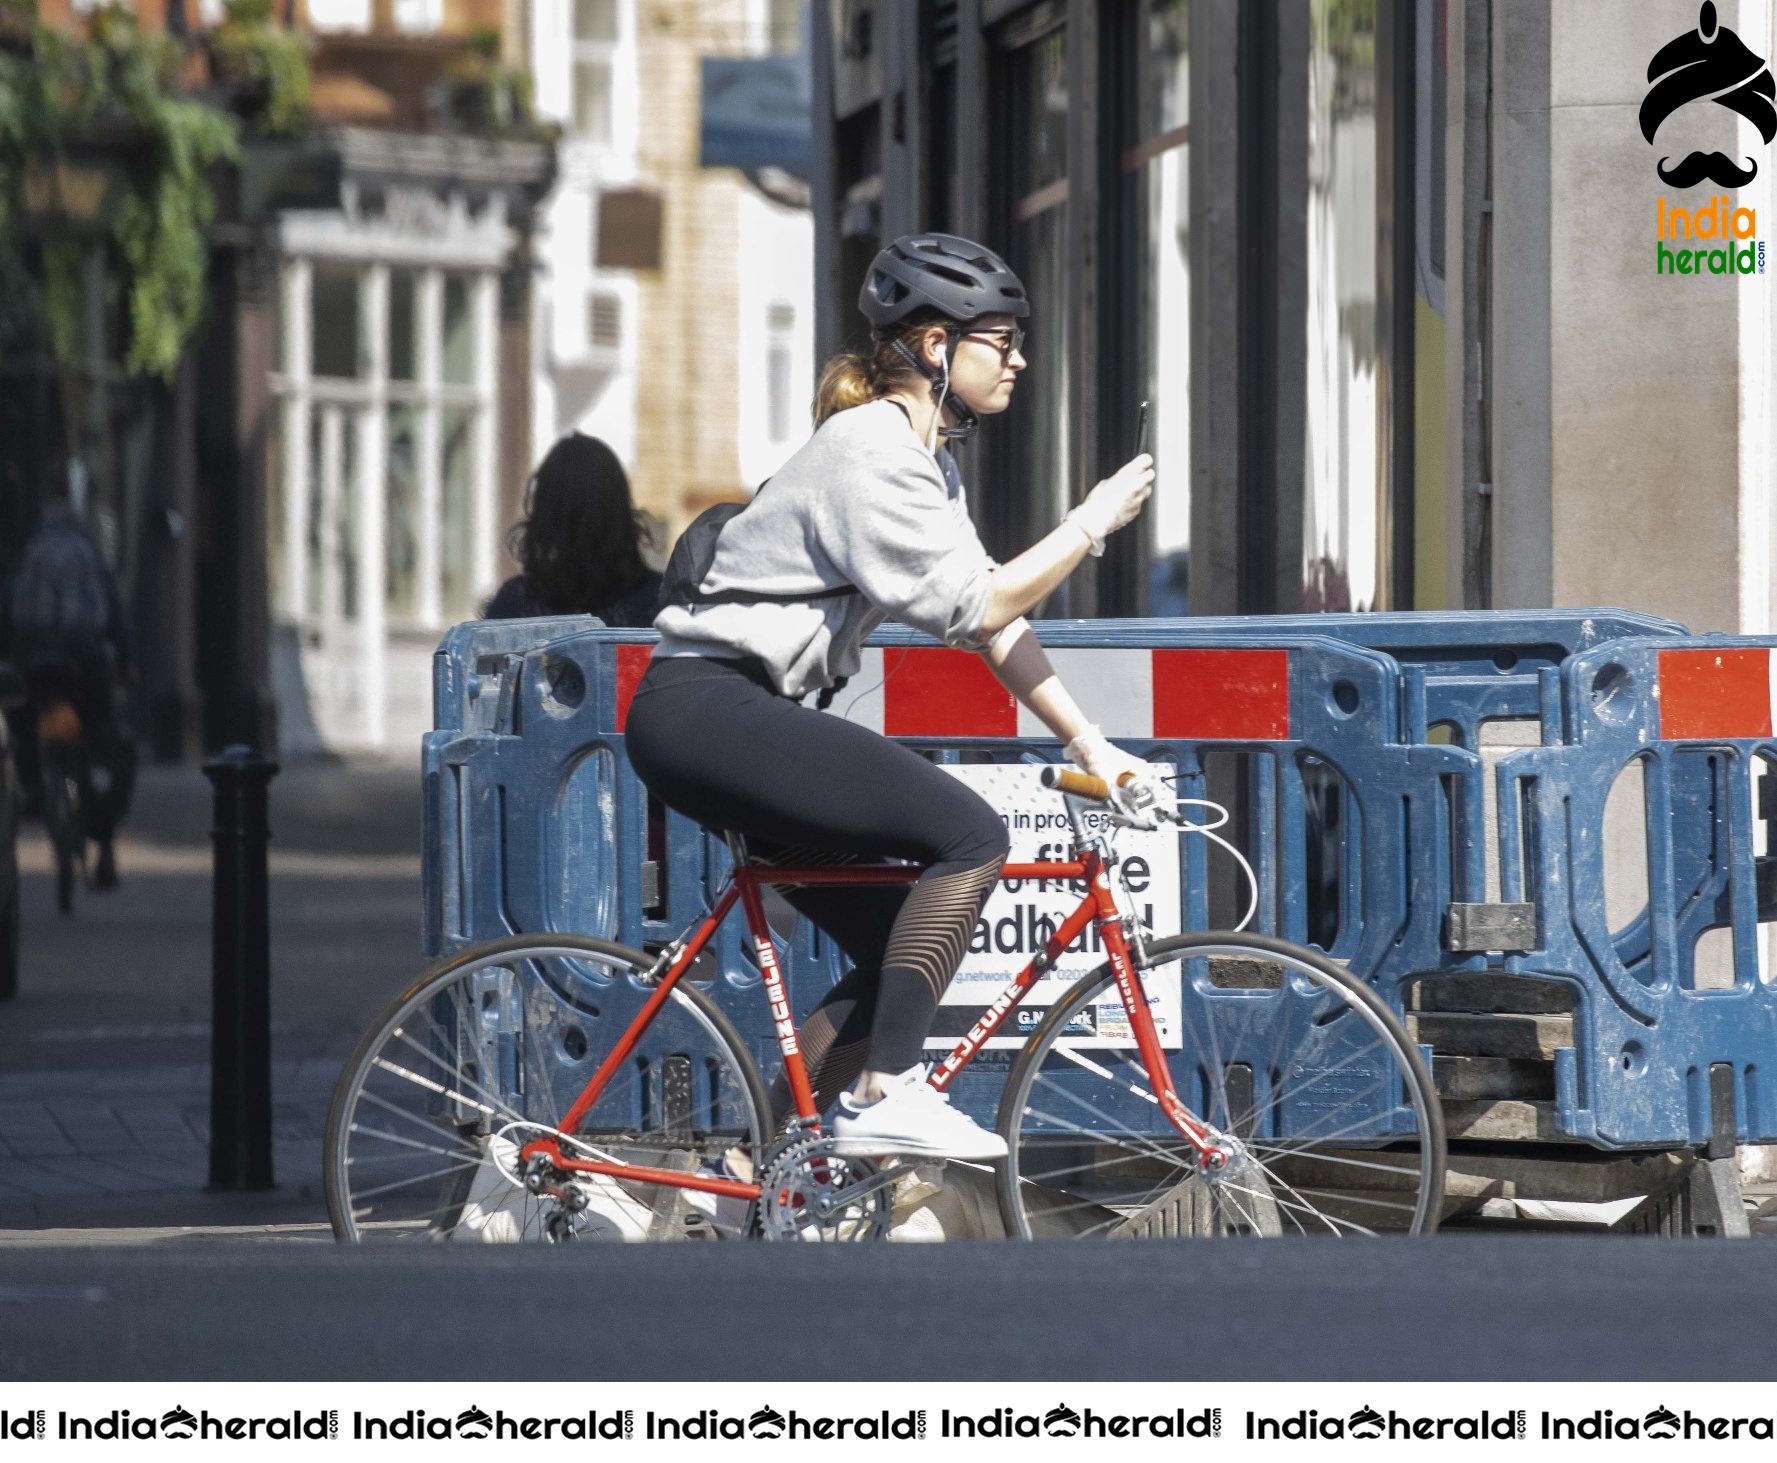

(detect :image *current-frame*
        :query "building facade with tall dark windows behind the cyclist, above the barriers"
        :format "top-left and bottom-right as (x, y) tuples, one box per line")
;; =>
(814, 0), (1777, 633)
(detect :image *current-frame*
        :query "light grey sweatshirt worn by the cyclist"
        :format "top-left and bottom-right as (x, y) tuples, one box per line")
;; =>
(654, 402), (993, 697)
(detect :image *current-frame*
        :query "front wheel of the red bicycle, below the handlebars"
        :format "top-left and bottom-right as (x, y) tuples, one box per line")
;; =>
(999, 933), (1445, 1239)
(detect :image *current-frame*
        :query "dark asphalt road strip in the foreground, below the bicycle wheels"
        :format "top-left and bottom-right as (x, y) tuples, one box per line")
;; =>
(0, 1235), (1777, 1381)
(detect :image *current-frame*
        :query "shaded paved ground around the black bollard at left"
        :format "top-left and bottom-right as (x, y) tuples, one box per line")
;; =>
(0, 763), (425, 1248)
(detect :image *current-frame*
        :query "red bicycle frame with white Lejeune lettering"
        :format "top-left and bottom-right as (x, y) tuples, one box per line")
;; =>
(519, 846), (1219, 1200)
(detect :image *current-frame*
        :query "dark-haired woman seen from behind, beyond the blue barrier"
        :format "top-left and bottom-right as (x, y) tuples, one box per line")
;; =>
(485, 432), (661, 629)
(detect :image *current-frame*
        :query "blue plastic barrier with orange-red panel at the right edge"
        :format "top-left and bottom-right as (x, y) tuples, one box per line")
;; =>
(1498, 636), (1777, 1147)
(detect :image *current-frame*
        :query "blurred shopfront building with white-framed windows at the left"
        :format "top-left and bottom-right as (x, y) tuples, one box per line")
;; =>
(0, 0), (554, 757)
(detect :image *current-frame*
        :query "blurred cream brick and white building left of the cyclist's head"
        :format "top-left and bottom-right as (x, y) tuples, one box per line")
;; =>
(530, 0), (814, 556)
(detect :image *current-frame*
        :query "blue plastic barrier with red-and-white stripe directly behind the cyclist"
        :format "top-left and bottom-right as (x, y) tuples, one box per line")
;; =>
(426, 620), (1480, 1136)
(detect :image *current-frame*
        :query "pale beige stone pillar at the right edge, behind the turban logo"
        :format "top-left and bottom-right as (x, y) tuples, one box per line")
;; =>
(1448, 0), (1755, 631)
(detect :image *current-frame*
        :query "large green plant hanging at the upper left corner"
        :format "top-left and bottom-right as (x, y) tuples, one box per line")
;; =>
(0, 0), (240, 379)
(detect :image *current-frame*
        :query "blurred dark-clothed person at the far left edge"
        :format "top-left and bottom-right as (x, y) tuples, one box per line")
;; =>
(5, 489), (137, 889)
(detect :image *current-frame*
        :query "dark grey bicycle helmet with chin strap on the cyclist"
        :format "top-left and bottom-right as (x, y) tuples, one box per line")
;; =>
(858, 233), (1031, 441)
